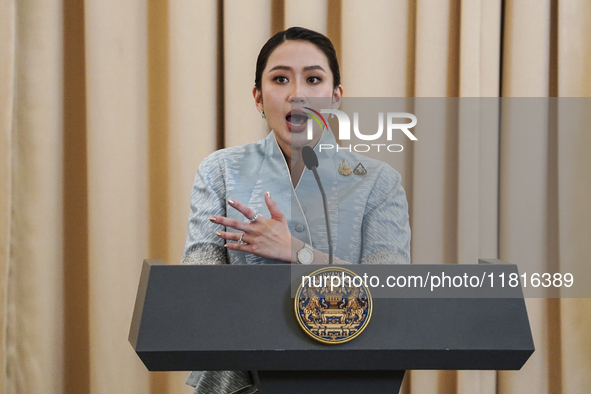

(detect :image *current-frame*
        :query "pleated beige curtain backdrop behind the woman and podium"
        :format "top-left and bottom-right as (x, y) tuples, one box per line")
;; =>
(0, 0), (591, 394)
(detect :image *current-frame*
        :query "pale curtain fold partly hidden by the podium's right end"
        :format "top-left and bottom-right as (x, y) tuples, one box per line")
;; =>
(498, 0), (558, 393)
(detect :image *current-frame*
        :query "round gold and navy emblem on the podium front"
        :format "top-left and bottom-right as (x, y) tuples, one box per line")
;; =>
(295, 266), (373, 344)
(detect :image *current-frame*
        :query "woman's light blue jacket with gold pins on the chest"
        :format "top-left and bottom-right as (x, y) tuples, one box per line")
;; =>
(183, 131), (410, 264)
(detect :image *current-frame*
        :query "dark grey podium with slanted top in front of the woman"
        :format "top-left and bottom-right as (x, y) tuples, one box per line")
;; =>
(129, 260), (534, 394)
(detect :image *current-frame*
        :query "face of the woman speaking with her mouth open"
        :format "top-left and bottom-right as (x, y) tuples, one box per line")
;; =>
(253, 40), (342, 158)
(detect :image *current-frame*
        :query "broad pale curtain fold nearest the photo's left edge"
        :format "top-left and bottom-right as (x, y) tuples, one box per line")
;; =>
(2, 1), (64, 393)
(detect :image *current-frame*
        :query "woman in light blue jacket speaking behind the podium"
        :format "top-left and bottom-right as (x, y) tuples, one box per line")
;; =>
(183, 27), (410, 393)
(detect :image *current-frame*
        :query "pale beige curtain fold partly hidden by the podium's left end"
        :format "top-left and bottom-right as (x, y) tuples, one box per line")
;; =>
(84, 0), (149, 393)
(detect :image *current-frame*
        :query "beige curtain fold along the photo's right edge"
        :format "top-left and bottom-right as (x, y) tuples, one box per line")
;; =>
(554, 0), (591, 393)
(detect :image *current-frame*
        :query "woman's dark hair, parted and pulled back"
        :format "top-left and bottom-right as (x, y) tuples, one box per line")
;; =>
(254, 27), (341, 90)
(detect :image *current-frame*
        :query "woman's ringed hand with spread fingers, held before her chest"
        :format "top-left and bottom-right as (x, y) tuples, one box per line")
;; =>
(209, 192), (292, 262)
